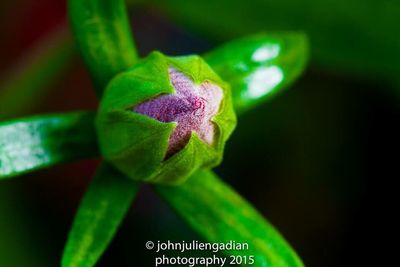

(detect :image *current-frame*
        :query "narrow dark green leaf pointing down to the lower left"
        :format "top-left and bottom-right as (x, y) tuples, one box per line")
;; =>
(61, 164), (139, 267)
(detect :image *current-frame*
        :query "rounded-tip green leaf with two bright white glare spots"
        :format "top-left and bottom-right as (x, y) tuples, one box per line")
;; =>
(204, 33), (308, 113)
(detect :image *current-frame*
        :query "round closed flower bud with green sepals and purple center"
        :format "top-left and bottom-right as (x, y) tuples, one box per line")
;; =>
(96, 52), (236, 184)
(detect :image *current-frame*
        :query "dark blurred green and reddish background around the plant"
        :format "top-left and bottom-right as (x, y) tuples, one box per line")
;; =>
(0, 0), (400, 267)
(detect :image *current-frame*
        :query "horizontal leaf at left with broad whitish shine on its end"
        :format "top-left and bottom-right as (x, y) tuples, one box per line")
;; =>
(0, 112), (98, 179)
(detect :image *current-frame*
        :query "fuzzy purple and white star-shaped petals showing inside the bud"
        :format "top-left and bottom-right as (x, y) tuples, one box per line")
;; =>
(134, 68), (223, 155)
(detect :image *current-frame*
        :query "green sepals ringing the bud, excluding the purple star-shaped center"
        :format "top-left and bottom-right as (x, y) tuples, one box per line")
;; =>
(96, 52), (236, 184)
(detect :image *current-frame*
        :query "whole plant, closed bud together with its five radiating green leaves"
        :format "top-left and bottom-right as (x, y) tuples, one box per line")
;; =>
(0, 0), (308, 267)
